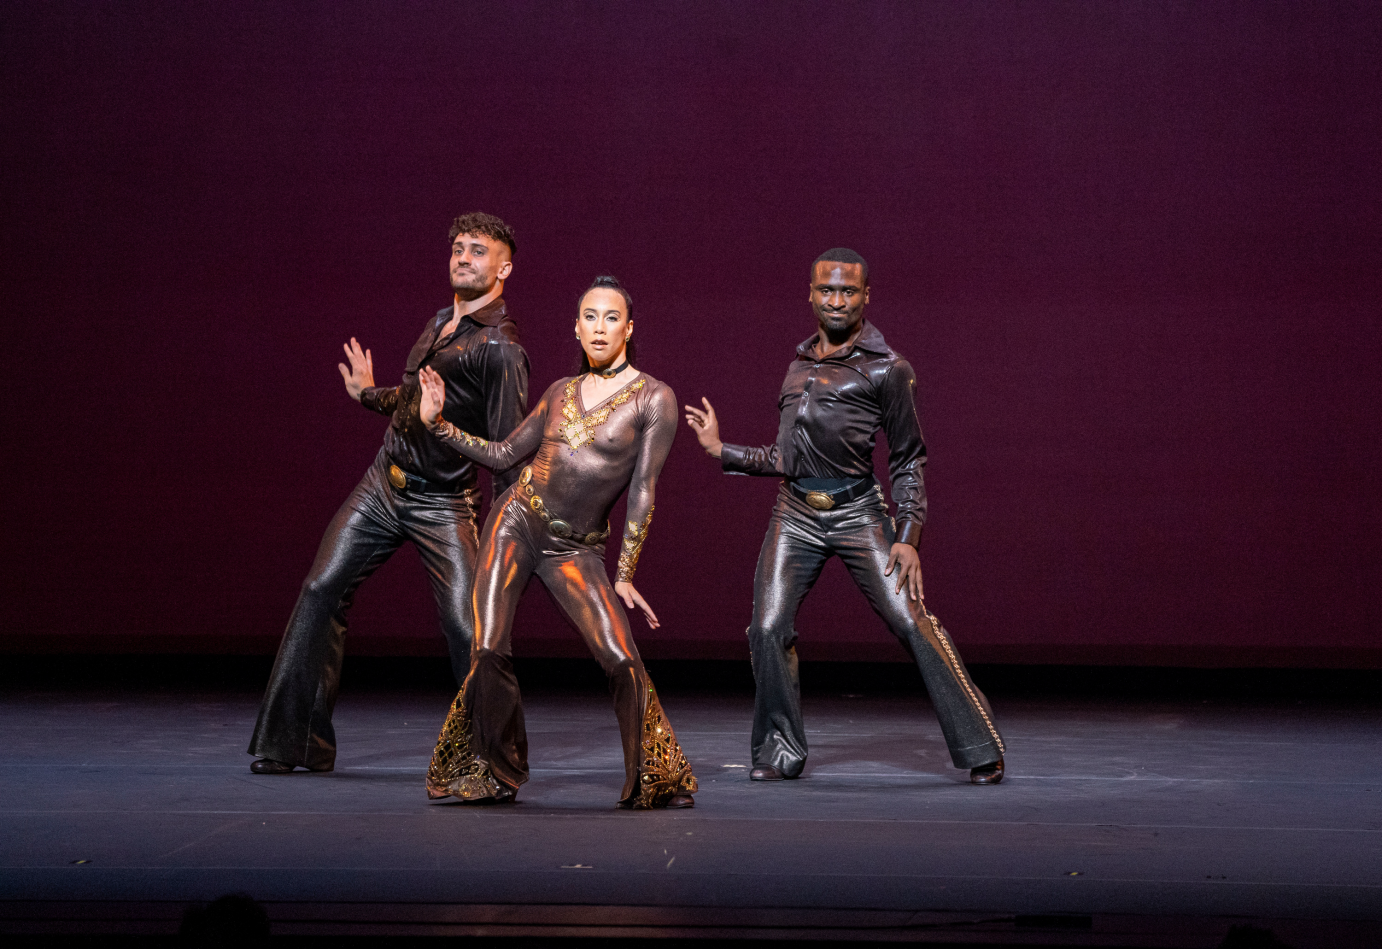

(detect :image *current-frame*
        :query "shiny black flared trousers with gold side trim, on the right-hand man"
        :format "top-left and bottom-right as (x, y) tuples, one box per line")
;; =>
(748, 486), (1003, 778)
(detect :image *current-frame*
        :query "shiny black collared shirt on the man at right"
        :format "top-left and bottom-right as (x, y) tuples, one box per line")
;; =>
(720, 320), (926, 547)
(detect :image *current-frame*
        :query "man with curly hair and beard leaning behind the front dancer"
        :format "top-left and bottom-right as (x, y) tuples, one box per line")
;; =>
(249, 211), (528, 775)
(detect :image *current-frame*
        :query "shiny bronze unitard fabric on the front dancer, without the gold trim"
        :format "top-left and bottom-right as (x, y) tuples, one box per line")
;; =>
(428, 373), (680, 804)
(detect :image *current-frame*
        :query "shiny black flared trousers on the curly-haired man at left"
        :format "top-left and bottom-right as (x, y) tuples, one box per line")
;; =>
(249, 452), (480, 771)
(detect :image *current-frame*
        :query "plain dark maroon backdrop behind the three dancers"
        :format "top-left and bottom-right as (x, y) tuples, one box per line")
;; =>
(0, 0), (1382, 662)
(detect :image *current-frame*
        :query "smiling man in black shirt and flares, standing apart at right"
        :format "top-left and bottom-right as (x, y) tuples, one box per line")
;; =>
(685, 247), (1003, 785)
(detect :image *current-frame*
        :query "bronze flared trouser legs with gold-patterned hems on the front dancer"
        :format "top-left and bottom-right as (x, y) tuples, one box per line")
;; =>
(427, 490), (697, 808)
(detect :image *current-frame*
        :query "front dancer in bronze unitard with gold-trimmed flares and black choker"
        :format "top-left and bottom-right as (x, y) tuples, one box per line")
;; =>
(420, 276), (697, 808)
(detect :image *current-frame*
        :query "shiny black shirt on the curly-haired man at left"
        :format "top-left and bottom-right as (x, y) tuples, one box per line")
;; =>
(359, 297), (528, 496)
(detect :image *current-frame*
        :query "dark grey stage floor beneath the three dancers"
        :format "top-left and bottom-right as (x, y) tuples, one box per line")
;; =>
(0, 665), (1382, 946)
